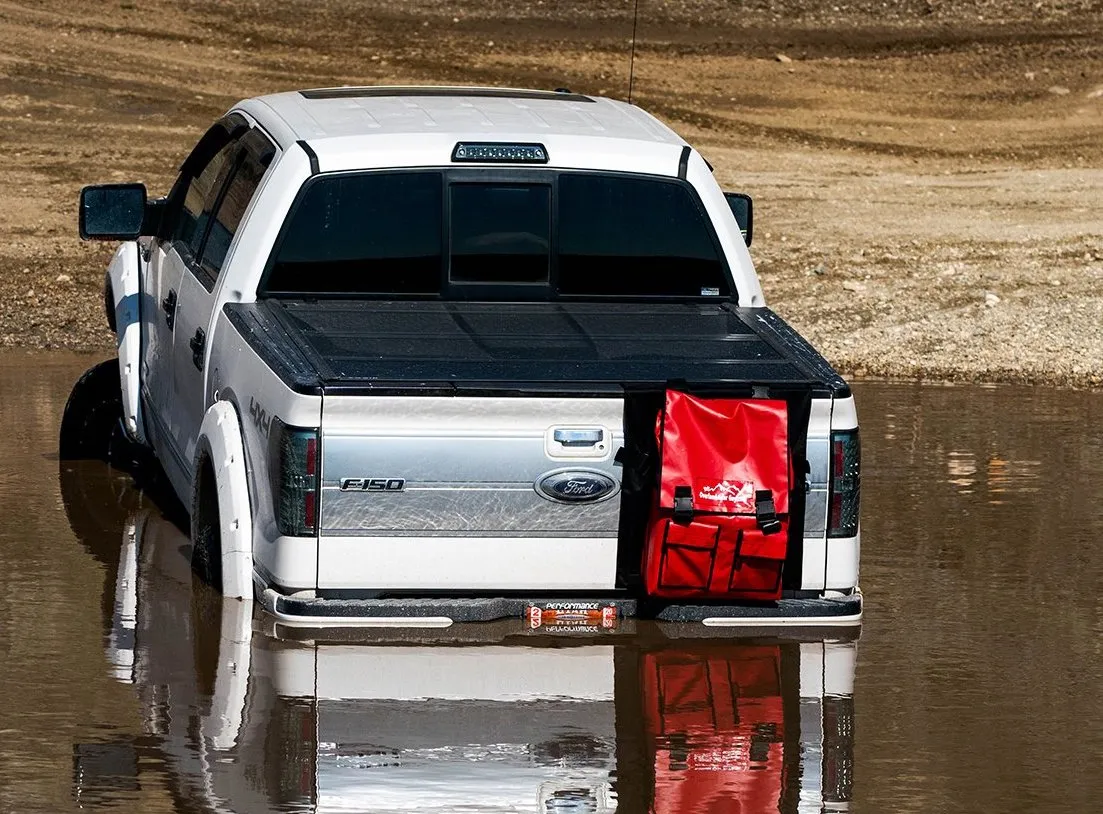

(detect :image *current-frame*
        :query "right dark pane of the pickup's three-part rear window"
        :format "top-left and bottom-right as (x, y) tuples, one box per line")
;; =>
(559, 174), (728, 297)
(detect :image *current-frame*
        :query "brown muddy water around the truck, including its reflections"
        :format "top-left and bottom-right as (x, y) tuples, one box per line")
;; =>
(0, 354), (1103, 813)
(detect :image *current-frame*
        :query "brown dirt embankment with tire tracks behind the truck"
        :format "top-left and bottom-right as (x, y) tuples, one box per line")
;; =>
(0, 0), (1103, 385)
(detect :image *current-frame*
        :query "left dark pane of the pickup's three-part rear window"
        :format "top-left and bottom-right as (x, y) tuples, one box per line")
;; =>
(267, 172), (443, 294)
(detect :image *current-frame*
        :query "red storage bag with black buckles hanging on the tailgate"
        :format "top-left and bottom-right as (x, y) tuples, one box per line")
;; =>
(643, 390), (791, 600)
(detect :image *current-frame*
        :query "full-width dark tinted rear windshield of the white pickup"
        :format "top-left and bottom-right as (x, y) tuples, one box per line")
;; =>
(263, 171), (731, 299)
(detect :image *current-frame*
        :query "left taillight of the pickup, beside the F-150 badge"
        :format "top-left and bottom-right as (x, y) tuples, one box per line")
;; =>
(268, 418), (319, 537)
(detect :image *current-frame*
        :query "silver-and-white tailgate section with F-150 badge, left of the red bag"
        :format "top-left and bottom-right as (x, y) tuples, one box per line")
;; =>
(318, 395), (624, 591)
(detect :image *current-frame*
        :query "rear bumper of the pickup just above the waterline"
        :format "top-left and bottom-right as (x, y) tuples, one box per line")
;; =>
(258, 588), (863, 629)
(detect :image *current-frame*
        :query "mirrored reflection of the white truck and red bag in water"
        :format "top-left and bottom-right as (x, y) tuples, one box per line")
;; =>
(63, 463), (856, 814)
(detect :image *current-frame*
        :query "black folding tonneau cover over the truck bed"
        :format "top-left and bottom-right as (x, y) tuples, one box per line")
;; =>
(225, 299), (848, 395)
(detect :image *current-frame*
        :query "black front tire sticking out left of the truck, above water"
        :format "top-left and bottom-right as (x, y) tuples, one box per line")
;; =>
(57, 360), (150, 473)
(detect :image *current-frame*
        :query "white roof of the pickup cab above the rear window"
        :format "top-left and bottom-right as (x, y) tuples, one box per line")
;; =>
(235, 86), (686, 174)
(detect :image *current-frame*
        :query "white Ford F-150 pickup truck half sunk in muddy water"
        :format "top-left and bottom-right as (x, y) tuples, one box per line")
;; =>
(79, 87), (861, 626)
